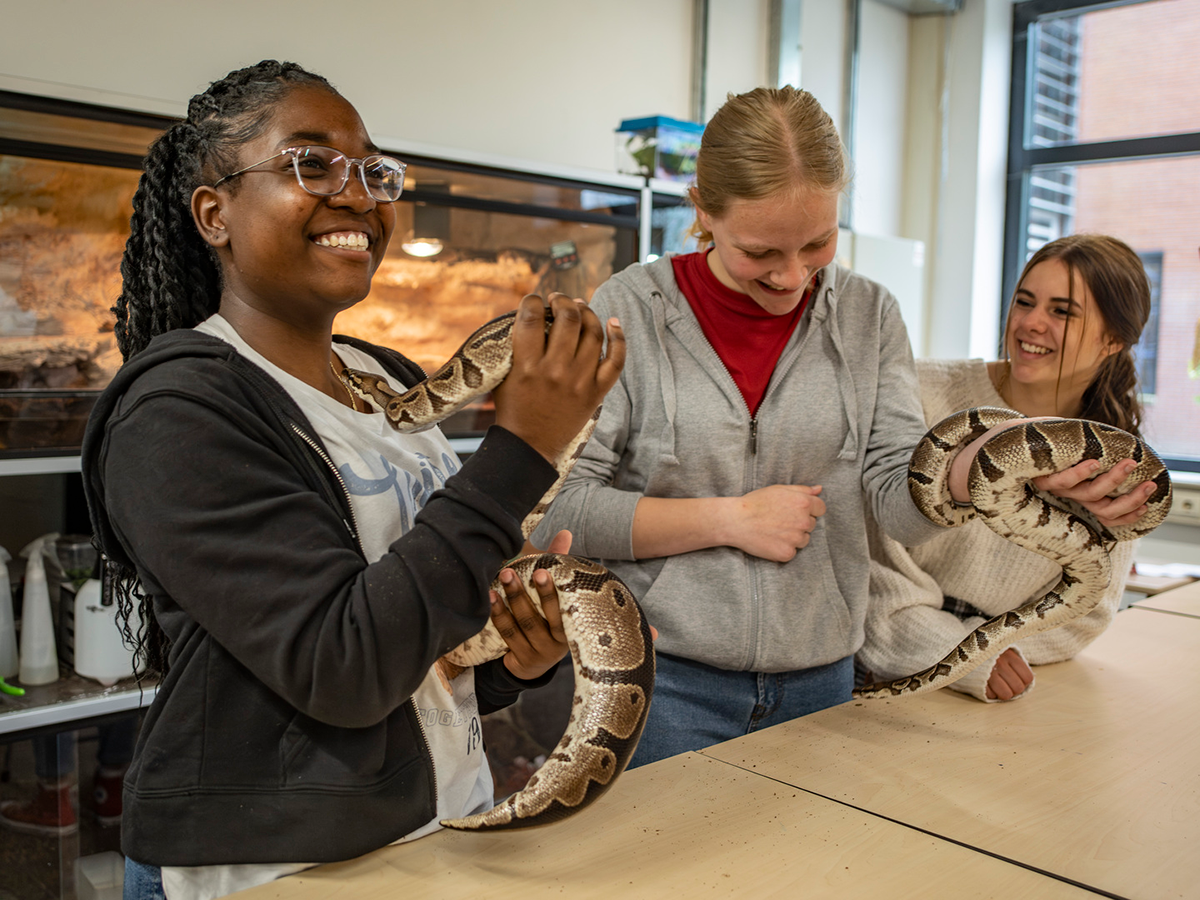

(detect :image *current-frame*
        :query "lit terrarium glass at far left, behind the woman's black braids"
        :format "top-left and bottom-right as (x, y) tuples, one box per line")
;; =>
(0, 156), (138, 451)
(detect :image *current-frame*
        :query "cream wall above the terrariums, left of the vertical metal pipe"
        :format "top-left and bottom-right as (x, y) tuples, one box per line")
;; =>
(0, 0), (696, 172)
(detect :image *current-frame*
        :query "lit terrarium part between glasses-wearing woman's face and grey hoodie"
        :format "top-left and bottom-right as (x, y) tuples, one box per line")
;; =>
(334, 157), (640, 438)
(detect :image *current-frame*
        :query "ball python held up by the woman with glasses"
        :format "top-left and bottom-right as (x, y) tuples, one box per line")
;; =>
(341, 310), (654, 830)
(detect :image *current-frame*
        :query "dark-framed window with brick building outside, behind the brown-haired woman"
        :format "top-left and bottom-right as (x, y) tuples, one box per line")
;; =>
(1004, 0), (1200, 472)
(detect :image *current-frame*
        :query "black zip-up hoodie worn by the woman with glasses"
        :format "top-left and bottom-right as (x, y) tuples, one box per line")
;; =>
(83, 329), (556, 866)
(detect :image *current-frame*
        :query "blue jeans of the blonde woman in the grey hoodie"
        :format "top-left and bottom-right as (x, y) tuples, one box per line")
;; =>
(629, 653), (854, 768)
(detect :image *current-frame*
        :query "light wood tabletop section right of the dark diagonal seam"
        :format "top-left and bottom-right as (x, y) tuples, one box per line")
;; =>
(702, 607), (1200, 900)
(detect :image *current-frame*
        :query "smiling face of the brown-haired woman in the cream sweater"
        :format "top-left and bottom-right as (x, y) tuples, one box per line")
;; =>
(1004, 258), (1120, 392)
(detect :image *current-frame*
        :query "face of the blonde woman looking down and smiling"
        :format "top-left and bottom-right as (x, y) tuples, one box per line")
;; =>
(696, 188), (839, 316)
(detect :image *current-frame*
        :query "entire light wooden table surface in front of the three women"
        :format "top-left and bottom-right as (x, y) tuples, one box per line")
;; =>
(239, 595), (1200, 900)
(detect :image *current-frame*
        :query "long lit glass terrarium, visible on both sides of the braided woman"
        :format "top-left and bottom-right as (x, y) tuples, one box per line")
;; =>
(0, 91), (641, 458)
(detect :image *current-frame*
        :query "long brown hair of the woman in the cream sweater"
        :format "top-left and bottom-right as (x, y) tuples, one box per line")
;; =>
(1001, 234), (1150, 434)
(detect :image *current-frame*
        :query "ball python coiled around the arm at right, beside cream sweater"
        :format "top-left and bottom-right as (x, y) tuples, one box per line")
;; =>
(854, 407), (1171, 698)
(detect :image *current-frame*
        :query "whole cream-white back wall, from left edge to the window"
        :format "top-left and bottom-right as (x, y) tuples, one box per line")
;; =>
(0, 0), (1010, 356)
